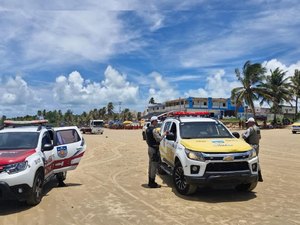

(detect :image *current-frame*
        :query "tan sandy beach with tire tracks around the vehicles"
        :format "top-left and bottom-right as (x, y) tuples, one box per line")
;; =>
(0, 129), (300, 225)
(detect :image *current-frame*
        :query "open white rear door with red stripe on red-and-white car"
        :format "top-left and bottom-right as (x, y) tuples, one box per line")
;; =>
(53, 126), (86, 173)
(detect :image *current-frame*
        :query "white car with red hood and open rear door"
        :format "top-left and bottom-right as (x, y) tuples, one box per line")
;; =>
(0, 120), (86, 205)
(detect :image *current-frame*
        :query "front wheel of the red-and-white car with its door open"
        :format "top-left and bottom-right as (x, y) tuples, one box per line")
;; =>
(26, 171), (44, 206)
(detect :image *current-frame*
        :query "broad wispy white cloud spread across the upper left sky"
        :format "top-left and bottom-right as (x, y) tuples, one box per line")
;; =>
(0, 10), (140, 70)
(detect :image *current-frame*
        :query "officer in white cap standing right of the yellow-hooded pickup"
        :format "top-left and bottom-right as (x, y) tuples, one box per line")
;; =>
(242, 117), (263, 182)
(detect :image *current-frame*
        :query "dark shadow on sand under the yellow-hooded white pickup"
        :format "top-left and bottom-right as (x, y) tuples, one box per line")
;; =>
(158, 175), (256, 203)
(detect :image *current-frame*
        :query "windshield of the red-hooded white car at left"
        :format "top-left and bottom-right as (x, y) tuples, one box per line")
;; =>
(0, 132), (39, 150)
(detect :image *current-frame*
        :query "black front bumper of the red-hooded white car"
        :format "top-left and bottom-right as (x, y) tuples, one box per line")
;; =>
(0, 181), (31, 200)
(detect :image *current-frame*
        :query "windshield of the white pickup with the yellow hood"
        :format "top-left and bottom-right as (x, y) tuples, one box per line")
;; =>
(180, 122), (233, 139)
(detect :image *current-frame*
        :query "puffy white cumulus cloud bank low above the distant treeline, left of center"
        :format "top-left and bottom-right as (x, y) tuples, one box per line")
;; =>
(54, 66), (139, 105)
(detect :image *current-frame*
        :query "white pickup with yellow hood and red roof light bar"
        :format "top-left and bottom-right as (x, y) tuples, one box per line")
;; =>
(160, 112), (258, 195)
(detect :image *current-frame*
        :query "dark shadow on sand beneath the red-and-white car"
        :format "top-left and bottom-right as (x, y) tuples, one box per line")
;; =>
(0, 177), (81, 216)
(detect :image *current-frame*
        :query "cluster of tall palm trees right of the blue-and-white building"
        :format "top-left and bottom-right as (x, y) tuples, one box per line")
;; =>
(231, 61), (300, 124)
